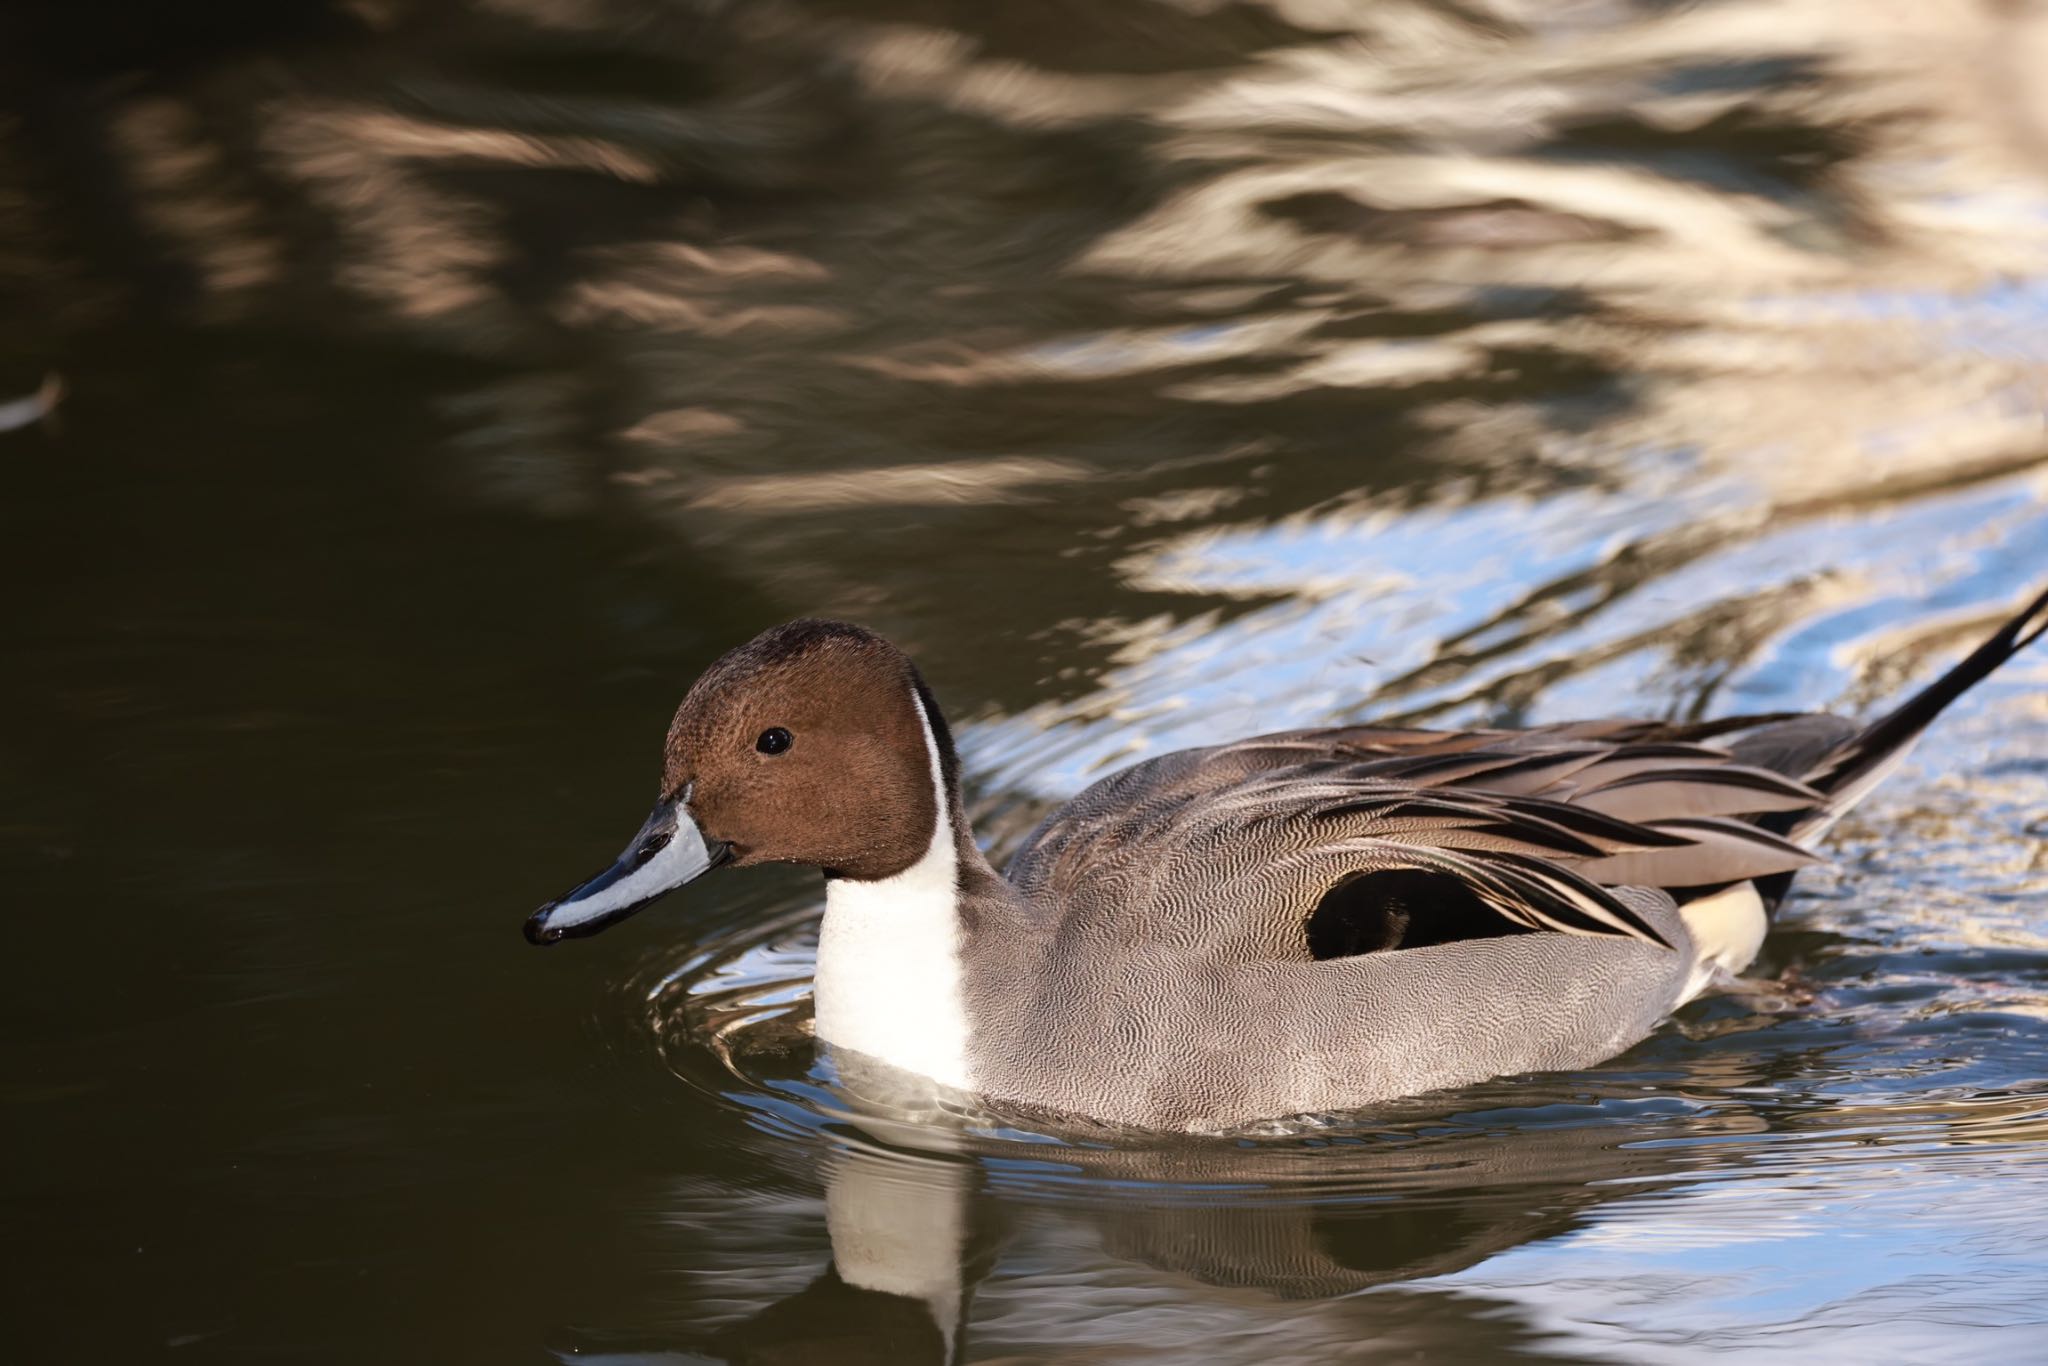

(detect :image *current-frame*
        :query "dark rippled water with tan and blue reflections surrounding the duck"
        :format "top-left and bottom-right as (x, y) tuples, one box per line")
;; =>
(0, 0), (2048, 1362)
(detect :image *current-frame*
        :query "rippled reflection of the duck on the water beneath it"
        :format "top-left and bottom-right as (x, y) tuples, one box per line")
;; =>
(565, 1112), (1763, 1366)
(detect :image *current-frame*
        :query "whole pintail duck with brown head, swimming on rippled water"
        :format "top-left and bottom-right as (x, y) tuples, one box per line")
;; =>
(524, 592), (2048, 1133)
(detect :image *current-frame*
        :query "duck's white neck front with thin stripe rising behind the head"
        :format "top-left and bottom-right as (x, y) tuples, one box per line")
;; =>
(815, 688), (1001, 1092)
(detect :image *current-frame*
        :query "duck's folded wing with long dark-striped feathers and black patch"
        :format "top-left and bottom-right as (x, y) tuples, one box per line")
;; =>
(1012, 723), (1821, 958)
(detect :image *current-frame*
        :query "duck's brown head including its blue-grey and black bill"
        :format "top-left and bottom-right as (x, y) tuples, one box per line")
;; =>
(526, 621), (954, 944)
